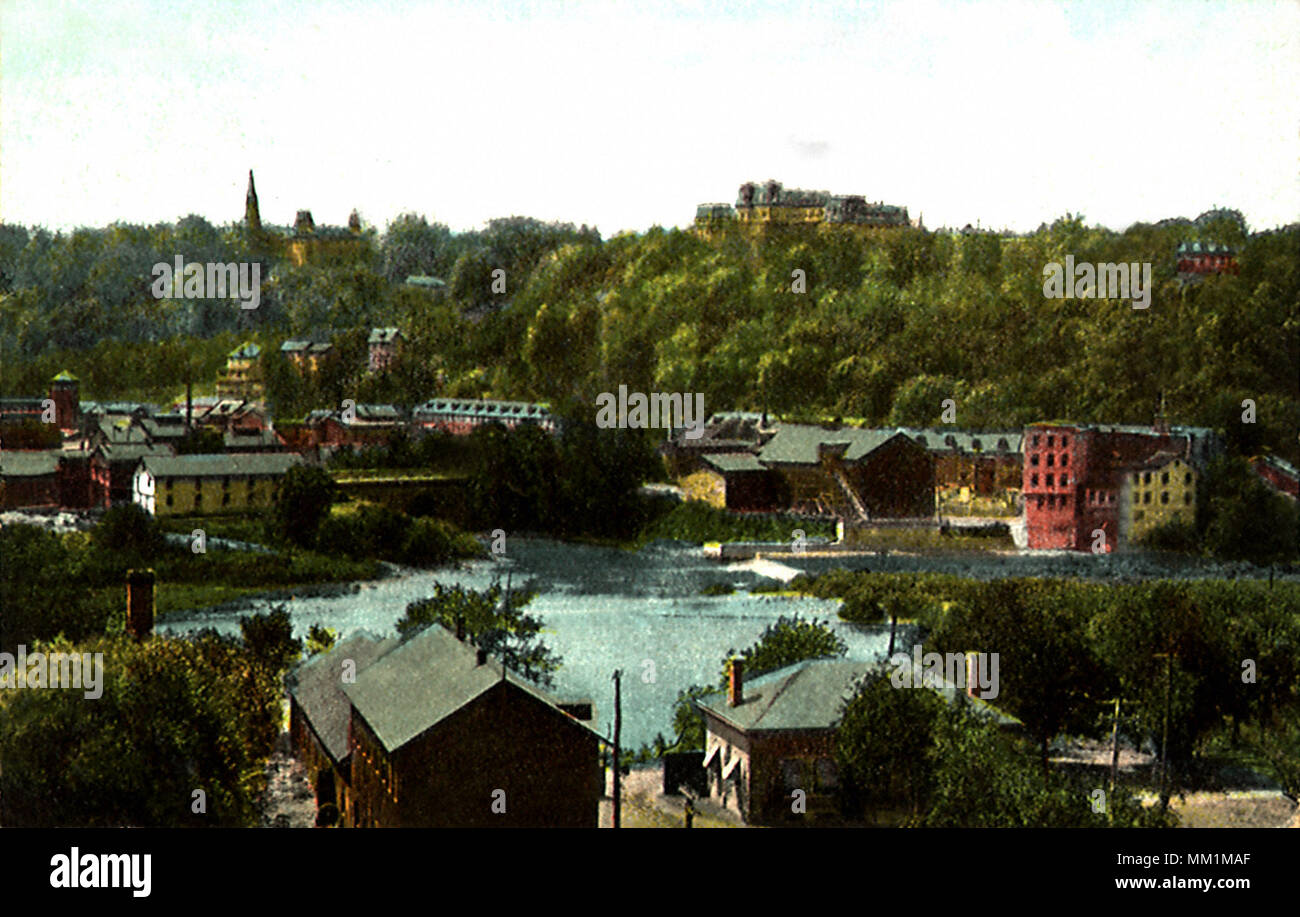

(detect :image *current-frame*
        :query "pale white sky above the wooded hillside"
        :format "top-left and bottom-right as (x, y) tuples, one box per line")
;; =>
(0, 0), (1300, 237)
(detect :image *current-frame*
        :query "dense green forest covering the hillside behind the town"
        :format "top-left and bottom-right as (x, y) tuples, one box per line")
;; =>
(0, 211), (1300, 460)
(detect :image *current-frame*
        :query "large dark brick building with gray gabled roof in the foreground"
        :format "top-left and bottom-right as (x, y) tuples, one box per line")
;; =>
(343, 624), (603, 827)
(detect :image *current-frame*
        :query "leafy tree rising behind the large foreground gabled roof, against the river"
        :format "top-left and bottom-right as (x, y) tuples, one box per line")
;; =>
(397, 583), (562, 685)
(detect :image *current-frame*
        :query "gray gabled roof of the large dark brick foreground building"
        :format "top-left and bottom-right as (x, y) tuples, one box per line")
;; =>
(343, 624), (598, 752)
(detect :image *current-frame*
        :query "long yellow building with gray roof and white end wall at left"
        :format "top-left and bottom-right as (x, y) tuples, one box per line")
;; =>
(131, 453), (302, 516)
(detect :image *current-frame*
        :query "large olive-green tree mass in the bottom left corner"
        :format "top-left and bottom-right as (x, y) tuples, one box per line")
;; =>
(0, 633), (281, 827)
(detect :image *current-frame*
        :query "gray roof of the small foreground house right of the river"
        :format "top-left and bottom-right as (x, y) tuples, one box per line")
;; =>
(696, 659), (1019, 732)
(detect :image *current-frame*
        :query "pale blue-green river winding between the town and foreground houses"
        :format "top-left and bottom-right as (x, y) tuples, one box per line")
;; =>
(157, 538), (1295, 748)
